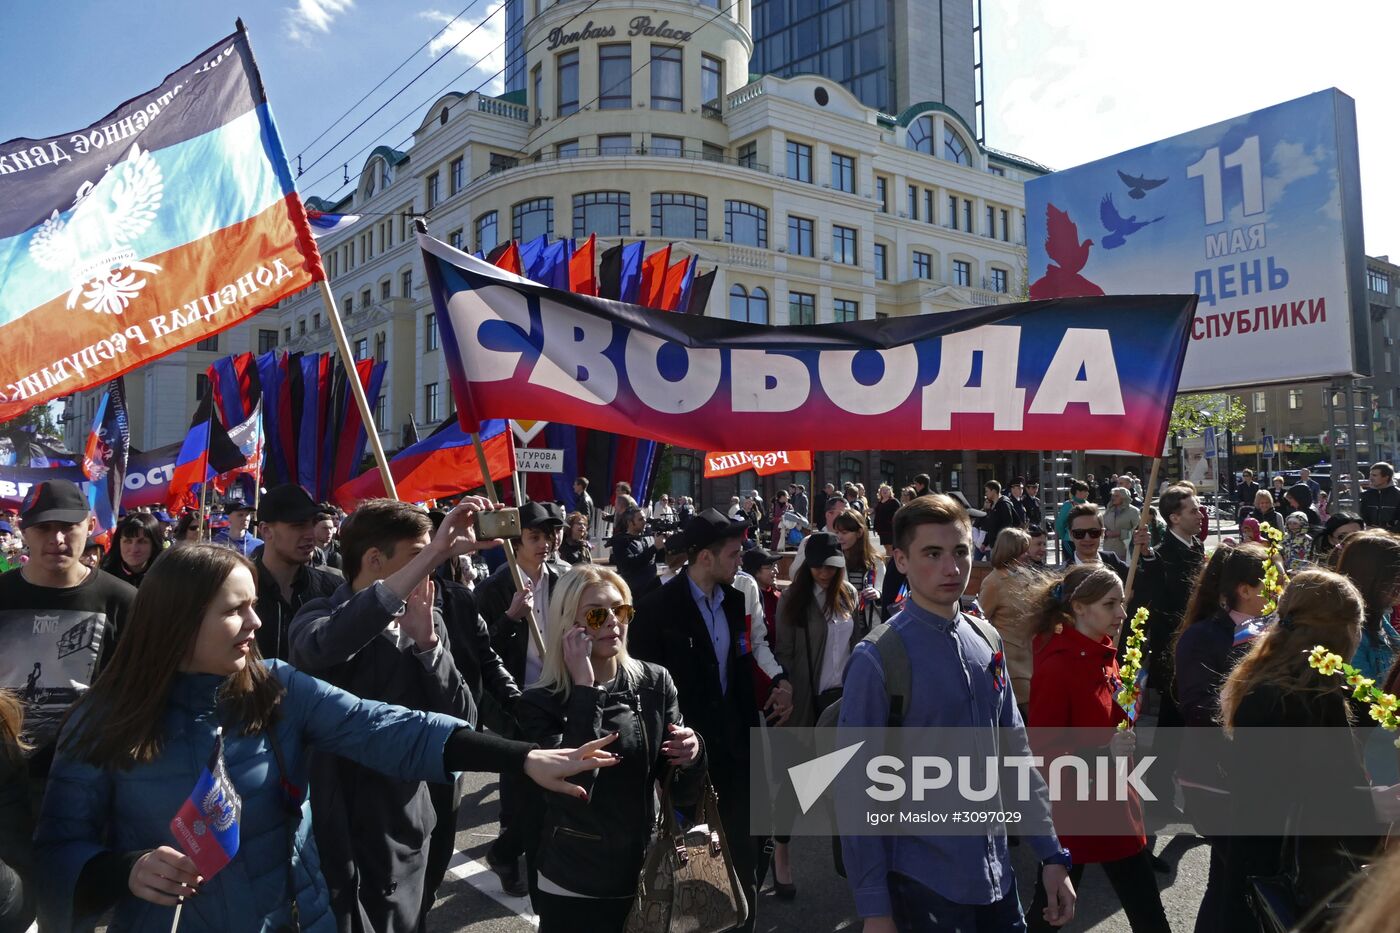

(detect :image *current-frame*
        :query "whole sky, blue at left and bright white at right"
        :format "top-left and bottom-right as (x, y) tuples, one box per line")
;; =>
(0, 0), (1400, 259)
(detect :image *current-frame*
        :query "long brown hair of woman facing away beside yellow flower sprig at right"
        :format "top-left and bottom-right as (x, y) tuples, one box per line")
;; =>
(1221, 570), (1365, 733)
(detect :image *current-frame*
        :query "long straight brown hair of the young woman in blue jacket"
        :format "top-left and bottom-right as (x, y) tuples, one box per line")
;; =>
(64, 542), (283, 769)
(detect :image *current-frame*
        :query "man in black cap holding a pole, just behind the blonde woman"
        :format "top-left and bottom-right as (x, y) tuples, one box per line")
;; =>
(476, 502), (568, 897)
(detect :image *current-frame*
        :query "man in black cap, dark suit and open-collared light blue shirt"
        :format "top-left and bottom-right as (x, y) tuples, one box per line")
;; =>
(627, 509), (759, 930)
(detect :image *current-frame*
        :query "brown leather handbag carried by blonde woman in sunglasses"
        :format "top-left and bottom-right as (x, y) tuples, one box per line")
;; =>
(624, 768), (749, 933)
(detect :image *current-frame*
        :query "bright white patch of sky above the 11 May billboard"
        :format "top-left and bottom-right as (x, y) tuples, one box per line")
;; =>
(983, 0), (1400, 255)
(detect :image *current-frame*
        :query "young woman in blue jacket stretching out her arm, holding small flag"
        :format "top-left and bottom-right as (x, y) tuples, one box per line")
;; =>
(35, 515), (615, 933)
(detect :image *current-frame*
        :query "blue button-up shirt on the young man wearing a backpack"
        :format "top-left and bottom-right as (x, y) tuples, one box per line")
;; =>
(840, 598), (1060, 916)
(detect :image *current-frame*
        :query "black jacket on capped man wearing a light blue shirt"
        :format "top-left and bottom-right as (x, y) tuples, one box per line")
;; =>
(627, 573), (757, 787)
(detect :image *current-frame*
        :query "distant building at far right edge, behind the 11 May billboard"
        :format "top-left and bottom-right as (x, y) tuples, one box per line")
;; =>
(1233, 256), (1400, 487)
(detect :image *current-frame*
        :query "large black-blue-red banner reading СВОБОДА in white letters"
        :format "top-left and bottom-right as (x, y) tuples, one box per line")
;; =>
(419, 234), (1196, 457)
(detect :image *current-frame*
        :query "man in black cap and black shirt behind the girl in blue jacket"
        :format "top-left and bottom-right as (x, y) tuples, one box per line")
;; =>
(253, 483), (344, 661)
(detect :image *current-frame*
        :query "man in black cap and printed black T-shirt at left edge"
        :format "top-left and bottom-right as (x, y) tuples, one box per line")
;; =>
(0, 479), (136, 792)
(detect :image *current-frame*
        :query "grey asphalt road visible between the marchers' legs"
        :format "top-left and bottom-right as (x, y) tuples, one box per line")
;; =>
(428, 776), (1210, 933)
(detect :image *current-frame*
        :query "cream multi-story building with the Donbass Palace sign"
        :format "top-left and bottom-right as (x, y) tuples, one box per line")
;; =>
(63, 0), (1046, 493)
